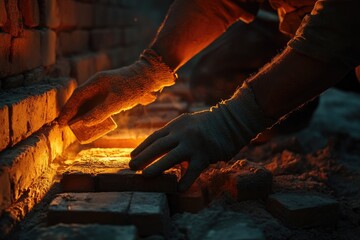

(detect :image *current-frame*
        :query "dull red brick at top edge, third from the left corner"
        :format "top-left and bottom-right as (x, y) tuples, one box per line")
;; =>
(39, 0), (60, 29)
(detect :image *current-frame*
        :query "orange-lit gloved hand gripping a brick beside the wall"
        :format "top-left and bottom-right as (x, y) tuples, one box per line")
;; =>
(59, 50), (175, 126)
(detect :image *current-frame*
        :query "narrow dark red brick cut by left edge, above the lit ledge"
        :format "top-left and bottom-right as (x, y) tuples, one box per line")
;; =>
(0, 32), (11, 77)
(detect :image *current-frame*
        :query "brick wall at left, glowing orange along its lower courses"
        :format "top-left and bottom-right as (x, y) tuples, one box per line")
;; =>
(0, 0), (170, 227)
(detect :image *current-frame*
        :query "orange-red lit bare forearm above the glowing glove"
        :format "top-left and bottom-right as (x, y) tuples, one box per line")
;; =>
(150, 0), (258, 71)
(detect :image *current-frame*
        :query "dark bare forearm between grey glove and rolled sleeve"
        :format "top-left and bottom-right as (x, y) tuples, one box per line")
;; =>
(248, 48), (351, 119)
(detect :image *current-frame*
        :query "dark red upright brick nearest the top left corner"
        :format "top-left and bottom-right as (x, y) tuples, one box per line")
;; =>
(3, 0), (23, 37)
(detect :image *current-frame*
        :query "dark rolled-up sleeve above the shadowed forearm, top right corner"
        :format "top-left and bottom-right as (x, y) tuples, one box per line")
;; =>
(288, 0), (360, 67)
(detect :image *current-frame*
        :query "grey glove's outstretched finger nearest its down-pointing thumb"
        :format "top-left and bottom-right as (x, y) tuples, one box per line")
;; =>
(143, 147), (187, 177)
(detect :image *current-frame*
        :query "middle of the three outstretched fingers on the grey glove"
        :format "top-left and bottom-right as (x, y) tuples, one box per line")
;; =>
(129, 136), (177, 170)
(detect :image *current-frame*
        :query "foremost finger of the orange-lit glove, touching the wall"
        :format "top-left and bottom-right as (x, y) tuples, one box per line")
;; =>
(58, 87), (96, 126)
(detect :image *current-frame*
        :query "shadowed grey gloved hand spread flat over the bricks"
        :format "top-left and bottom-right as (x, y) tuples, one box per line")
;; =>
(129, 83), (270, 191)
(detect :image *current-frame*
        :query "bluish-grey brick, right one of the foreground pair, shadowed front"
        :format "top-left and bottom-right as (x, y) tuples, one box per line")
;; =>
(128, 192), (170, 236)
